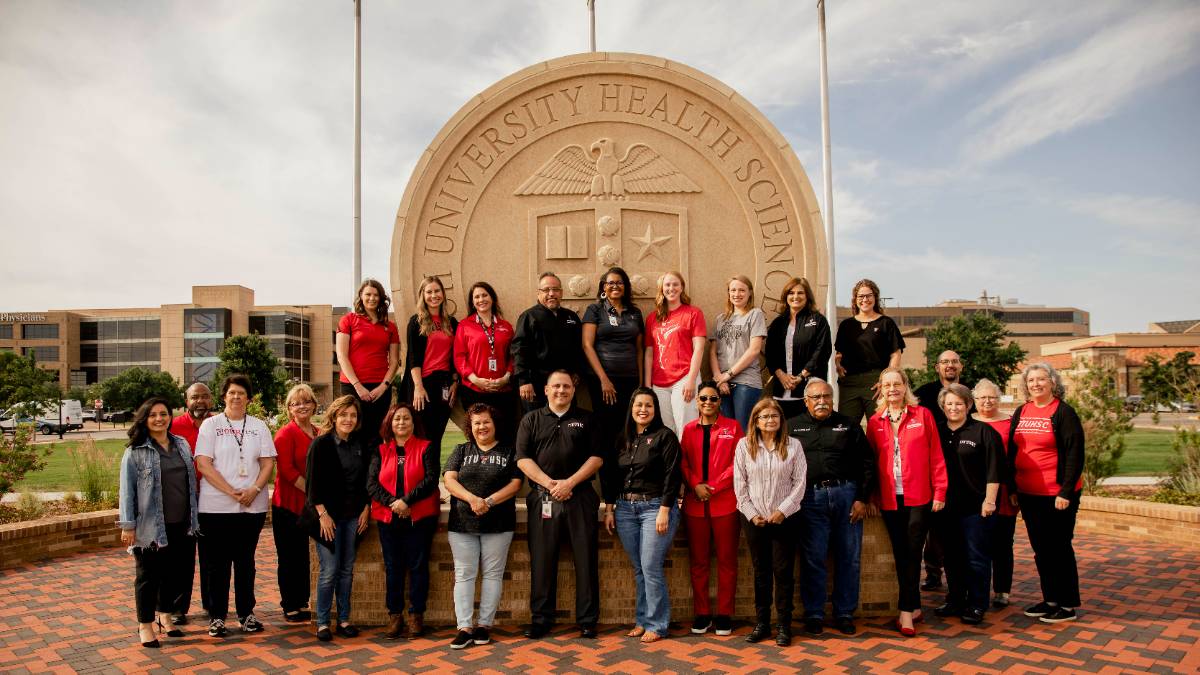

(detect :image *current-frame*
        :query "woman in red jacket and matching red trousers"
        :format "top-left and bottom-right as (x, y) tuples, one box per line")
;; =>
(680, 381), (745, 635)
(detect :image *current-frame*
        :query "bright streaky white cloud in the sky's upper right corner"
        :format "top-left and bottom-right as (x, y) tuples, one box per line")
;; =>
(964, 4), (1200, 162)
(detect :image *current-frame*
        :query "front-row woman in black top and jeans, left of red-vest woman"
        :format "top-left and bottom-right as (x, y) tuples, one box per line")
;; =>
(305, 395), (370, 641)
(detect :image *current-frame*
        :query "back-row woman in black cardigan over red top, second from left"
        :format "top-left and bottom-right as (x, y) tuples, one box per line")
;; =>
(401, 276), (458, 448)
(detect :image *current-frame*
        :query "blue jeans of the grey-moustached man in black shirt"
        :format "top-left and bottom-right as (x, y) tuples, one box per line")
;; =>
(799, 483), (863, 620)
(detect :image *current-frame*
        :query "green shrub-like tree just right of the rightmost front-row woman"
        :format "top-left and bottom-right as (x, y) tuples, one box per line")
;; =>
(1068, 360), (1133, 492)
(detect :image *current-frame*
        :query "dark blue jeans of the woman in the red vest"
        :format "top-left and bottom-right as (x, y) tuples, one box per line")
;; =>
(379, 516), (438, 614)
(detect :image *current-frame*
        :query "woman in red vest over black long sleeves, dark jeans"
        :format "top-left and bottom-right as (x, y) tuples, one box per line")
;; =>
(367, 404), (440, 640)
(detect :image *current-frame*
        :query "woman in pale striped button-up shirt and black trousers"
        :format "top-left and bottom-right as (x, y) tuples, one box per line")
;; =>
(733, 399), (808, 647)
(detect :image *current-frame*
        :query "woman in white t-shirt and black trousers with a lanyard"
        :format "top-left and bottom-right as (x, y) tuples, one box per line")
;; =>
(196, 374), (275, 638)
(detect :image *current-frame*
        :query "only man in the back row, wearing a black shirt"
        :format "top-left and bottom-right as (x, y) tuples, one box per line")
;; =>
(509, 271), (583, 413)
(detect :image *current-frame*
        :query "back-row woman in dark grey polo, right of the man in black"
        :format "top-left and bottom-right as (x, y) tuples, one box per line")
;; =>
(583, 267), (644, 458)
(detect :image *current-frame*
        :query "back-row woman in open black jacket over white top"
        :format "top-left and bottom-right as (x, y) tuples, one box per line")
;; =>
(767, 277), (833, 417)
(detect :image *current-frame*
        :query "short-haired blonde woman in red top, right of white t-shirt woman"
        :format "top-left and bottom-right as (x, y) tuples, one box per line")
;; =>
(271, 384), (317, 622)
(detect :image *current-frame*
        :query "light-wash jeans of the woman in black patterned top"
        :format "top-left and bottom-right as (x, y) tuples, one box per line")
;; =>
(448, 532), (512, 631)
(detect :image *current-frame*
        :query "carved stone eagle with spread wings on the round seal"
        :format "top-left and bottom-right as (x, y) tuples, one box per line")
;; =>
(516, 138), (700, 199)
